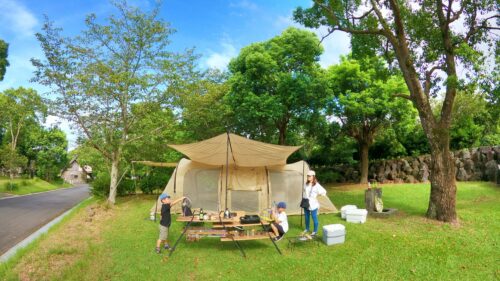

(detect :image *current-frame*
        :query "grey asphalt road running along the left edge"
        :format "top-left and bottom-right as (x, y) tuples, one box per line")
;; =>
(0, 185), (90, 255)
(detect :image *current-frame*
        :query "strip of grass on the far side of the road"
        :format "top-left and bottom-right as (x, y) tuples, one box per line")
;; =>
(0, 178), (71, 195)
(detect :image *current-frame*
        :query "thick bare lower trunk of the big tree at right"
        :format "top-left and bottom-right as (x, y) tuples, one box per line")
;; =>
(427, 132), (458, 223)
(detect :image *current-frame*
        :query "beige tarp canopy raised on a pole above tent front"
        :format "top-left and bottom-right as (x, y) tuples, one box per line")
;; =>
(169, 133), (302, 167)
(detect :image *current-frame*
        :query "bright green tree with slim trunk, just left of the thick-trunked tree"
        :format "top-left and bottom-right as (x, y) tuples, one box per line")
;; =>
(328, 57), (416, 183)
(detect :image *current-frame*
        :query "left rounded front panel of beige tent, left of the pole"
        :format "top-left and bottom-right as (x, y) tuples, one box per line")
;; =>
(184, 169), (220, 211)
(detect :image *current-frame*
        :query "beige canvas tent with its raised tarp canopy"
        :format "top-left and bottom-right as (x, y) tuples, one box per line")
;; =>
(152, 134), (337, 214)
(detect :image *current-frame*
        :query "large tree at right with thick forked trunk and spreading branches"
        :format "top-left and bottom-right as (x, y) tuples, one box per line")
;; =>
(294, 0), (500, 222)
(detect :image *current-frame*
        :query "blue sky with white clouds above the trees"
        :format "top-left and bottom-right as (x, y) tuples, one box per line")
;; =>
(0, 0), (350, 149)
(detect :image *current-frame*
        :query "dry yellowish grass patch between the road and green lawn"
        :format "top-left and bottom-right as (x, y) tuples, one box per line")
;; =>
(14, 203), (114, 280)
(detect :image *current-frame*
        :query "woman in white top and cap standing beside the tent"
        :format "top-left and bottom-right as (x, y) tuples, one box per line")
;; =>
(302, 170), (326, 236)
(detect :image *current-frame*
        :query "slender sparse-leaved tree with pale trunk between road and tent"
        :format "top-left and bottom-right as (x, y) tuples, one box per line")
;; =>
(32, 1), (197, 204)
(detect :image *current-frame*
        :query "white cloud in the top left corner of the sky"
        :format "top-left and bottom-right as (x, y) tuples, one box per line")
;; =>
(0, 0), (38, 36)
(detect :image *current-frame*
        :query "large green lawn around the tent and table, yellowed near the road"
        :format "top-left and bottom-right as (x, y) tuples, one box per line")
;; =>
(0, 180), (500, 280)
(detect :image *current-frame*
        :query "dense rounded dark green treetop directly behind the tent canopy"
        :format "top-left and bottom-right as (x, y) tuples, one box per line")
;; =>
(227, 28), (325, 144)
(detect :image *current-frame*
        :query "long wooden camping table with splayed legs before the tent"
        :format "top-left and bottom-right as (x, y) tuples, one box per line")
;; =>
(169, 211), (282, 257)
